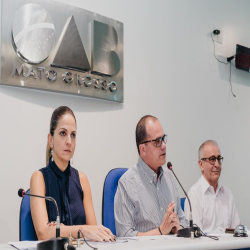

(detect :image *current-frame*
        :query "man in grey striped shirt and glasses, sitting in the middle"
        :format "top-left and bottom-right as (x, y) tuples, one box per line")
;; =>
(114, 116), (188, 236)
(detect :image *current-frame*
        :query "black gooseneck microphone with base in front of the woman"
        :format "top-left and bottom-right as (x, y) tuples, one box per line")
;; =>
(18, 189), (75, 250)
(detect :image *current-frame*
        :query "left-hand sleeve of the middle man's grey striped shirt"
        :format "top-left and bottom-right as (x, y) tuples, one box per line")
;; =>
(114, 179), (138, 237)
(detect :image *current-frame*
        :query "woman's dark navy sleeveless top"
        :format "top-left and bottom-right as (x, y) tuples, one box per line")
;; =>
(40, 161), (86, 225)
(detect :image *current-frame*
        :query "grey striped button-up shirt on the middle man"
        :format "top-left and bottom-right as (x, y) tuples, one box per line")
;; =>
(114, 157), (188, 237)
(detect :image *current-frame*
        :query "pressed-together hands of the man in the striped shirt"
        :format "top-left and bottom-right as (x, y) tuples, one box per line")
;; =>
(160, 201), (176, 234)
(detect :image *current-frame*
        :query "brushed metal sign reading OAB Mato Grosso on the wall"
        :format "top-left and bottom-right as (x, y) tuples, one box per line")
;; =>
(1, 0), (123, 102)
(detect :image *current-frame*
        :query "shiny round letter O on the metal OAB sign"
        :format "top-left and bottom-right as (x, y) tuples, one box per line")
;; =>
(12, 3), (55, 64)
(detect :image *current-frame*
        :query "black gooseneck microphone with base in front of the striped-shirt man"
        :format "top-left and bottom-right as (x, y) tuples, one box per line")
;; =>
(167, 162), (201, 239)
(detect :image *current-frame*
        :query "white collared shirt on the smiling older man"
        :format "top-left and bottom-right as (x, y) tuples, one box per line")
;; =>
(185, 176), (240, 233)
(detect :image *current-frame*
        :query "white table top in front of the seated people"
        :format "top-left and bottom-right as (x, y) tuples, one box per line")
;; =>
(0, 234), (250, 250)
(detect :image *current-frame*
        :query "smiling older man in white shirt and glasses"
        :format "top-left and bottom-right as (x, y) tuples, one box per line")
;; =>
(185, 140), (240, 232)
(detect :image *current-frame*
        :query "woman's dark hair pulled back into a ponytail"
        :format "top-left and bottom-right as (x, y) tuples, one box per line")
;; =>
(46, 106), (76, 165)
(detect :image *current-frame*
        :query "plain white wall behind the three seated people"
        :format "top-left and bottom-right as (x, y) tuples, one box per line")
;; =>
(0, 0), (250, 243)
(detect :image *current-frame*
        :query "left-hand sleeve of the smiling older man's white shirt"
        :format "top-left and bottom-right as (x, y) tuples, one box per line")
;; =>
(184, 189), (203, 230)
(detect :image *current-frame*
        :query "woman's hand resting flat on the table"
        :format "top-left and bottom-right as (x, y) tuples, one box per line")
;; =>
(81, 225), (115, 242)
